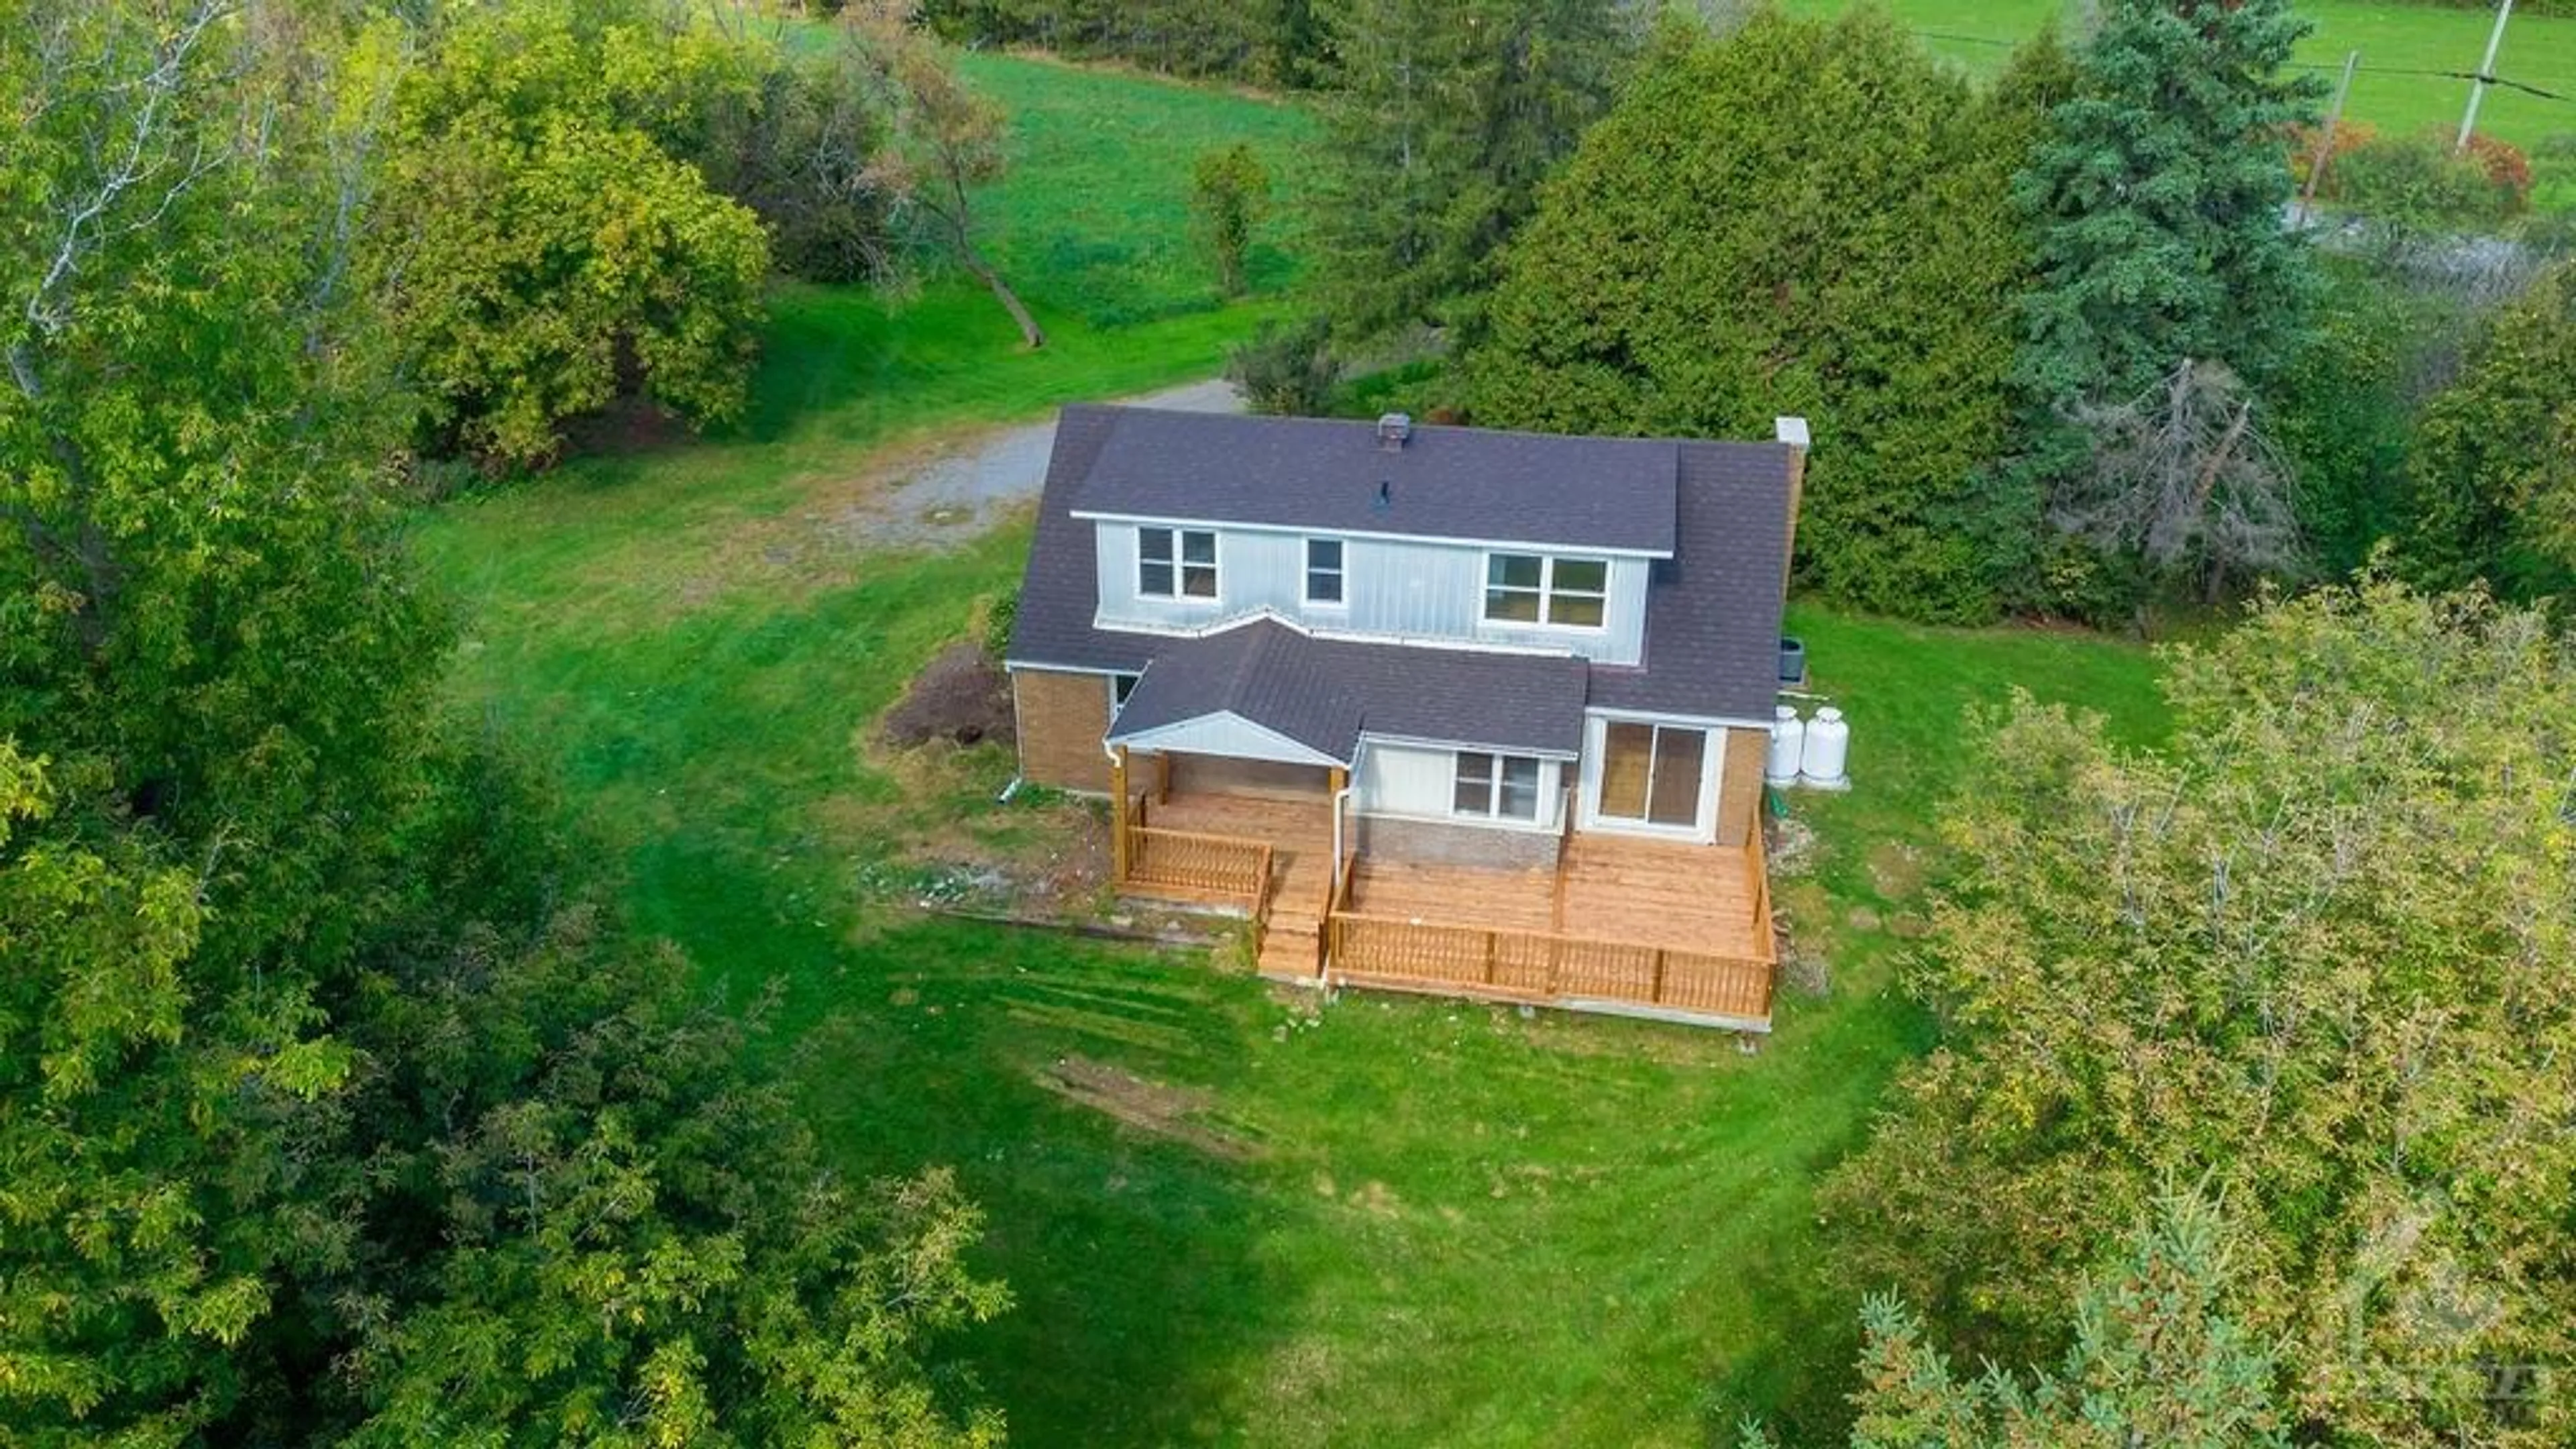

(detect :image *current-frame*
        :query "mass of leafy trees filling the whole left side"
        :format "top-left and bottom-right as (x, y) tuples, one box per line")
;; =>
(0, 0), (1007, 1446)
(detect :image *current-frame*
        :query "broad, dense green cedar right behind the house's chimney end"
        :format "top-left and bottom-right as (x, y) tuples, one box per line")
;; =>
(1466, 13), (2051, 619)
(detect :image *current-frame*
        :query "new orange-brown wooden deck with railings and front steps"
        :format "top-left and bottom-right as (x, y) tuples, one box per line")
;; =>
(1123, 778), (1778, 1031)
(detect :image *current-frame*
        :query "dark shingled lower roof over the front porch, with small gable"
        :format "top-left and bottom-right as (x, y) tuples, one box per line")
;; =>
(1110, 619), (1587, 763)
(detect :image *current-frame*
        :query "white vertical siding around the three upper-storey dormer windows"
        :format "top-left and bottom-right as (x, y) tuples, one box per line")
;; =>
(1095, 523), (1651, 665)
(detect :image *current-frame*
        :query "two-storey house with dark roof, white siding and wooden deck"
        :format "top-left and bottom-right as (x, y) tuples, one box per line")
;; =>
(1007, 407), (1806, 1026)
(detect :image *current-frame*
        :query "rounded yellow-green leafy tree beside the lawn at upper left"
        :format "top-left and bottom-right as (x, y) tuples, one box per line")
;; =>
(378, 0), (767, 464)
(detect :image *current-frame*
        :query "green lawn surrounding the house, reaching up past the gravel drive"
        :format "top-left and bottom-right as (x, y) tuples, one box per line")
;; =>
(415, 45), (2164, 1446)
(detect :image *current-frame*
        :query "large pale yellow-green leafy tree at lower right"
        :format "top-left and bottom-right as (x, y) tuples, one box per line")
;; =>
(1829, 583), (2576, 1449)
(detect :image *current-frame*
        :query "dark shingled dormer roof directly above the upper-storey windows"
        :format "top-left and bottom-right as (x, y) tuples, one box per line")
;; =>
(1074, 407), (1677, 554)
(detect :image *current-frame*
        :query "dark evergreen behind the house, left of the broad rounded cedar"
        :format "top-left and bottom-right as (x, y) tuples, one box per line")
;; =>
(1316, 0), (1641, 337)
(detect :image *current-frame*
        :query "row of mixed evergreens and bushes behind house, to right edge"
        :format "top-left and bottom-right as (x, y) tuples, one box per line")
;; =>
(1256, 0), (2576, 627)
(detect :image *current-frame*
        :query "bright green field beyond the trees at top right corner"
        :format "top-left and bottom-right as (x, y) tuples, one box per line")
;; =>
(1782, 0), (2576, 147)
